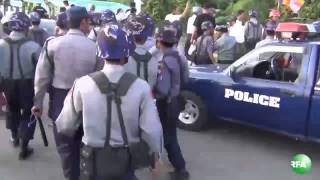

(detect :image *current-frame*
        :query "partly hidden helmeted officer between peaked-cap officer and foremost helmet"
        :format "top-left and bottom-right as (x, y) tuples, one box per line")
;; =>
(88, 9), (117, 41)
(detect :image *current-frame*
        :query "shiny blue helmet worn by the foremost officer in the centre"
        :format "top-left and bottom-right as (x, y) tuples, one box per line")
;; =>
(97, 23), (129, 61)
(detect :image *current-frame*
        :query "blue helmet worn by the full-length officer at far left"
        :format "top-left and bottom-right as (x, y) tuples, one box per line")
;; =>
(8, 12), (31, 31)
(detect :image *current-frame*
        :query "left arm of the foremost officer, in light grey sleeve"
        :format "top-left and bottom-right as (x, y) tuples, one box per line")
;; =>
(56, 82), (82, 137)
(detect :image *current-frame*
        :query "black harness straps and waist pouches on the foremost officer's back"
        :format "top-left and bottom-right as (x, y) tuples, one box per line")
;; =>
(80, 71), (152, 180)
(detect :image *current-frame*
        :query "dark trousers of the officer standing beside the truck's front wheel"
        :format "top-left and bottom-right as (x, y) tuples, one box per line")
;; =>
(156, 98), (186, 171)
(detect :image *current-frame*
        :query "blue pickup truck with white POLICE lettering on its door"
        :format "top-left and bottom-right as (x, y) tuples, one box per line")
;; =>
(179, 42), (320, 142)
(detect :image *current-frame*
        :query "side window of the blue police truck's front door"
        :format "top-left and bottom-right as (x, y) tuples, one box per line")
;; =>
(236, 47), (304, 83)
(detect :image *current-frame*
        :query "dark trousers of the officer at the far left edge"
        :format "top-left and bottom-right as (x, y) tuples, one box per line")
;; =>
(4, 79), (36, 142)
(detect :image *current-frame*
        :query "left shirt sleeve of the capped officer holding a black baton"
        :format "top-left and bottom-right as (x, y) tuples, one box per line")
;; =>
(34, 42), (53, 108)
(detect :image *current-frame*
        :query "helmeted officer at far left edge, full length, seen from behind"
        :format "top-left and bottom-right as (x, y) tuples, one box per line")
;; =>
(0, 12), (41, 160)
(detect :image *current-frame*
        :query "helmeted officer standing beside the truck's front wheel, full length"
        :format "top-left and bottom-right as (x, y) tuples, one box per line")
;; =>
(155, 30), (189, 179)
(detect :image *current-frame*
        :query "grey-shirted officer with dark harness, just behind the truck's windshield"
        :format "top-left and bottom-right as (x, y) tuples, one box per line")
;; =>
(244, 10), (263, 52)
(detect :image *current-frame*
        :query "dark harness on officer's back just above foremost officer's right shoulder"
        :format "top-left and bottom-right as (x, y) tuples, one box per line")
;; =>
(131, 51), (152, 82)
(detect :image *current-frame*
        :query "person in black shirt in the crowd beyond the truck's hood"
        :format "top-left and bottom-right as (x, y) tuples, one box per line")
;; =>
(191, 3), (216, 43)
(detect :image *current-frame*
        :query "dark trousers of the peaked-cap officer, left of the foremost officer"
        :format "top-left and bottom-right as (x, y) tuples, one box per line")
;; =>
(49, 87), (83, 180)
